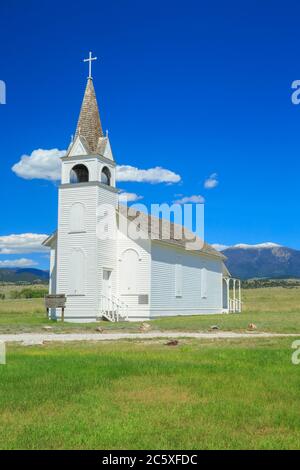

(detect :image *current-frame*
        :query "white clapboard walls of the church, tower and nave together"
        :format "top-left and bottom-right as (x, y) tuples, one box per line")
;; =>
(52, 184), (223, 321)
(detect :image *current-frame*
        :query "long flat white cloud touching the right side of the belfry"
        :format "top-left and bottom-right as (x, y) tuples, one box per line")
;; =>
(117, 165), (181, 184)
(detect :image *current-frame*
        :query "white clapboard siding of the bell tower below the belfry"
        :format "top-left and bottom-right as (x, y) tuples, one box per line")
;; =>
(57, 185), (116, 320)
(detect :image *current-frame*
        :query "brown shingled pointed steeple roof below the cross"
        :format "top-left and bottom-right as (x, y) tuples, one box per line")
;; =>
(75, 77), (103, 153)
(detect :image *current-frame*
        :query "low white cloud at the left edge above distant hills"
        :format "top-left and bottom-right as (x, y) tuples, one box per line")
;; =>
(0, 233), (48, 255)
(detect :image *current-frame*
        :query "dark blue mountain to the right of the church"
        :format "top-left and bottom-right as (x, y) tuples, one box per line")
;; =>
(221, 242), (300, 279)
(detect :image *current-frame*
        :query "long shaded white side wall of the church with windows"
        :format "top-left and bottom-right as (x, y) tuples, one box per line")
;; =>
(150, 242), (222, 316)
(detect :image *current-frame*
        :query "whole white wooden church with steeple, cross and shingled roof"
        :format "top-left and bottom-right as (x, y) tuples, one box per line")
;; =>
(44, 54), (241, 322)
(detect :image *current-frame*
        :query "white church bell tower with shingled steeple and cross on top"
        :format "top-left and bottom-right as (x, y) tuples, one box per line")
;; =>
(57, 53), (118, 321)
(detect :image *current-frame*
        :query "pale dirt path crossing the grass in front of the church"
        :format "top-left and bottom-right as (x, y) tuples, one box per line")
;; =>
(0, 331), (300, 346)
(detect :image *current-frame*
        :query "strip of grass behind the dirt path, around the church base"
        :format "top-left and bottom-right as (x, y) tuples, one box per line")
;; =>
(0, 287), (300, 333)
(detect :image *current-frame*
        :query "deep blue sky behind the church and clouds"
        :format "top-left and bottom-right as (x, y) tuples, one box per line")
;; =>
(0, 0), (300, 268)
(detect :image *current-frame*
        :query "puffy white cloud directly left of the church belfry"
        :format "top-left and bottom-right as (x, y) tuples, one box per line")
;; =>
(12, 149), (66, 181)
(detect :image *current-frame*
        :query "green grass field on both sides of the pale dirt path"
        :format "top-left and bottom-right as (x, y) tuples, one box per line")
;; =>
(0, 287), (300, 449)
